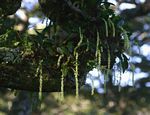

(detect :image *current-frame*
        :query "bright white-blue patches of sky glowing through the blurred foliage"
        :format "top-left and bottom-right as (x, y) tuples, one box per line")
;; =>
(13, 0), (150, 93)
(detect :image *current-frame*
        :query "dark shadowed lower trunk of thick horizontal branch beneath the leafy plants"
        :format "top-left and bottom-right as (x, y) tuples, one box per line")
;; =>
(0, 64), (74, 92)
